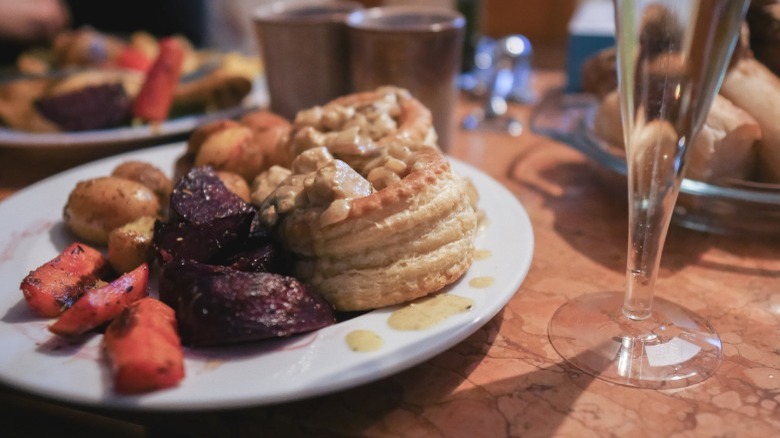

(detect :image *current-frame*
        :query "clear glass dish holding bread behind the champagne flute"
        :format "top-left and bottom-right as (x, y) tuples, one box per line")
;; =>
(530, 92), (780, 237)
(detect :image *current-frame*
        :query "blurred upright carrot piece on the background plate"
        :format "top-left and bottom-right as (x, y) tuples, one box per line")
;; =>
(133, 38), (184, 123)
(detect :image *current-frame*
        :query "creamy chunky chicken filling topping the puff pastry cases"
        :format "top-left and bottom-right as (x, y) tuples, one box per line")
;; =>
(252, 87), (427, 226)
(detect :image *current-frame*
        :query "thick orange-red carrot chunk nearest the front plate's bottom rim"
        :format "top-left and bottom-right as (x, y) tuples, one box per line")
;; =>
(103, 297), (184, 394)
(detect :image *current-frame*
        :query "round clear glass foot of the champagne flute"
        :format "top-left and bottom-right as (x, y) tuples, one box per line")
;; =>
(548, 292), (722, 389)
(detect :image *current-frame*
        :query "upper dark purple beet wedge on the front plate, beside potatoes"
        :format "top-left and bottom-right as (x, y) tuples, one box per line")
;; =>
(154, 167), (257, 264)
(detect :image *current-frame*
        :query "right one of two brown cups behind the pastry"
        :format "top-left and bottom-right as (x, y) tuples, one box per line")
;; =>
(347, 6), (466, 150)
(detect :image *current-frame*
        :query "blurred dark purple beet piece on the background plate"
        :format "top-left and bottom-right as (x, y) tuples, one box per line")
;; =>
(35, 83), (131, 131)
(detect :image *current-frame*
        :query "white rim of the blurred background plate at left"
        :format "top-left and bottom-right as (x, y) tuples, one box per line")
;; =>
(0, 77), (268, 151)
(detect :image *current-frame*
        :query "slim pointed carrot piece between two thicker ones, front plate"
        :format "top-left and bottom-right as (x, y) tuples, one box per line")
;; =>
(49, 263), (149, 336)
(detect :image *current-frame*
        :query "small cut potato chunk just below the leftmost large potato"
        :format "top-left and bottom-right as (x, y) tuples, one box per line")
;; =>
(108, 216), (155, 273)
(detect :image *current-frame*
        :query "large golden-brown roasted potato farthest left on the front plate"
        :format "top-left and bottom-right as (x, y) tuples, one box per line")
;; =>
(63, 176), (160, 245)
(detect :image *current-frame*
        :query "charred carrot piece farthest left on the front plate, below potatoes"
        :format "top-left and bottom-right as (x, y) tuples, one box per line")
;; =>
(20, 243), (109, 318)
